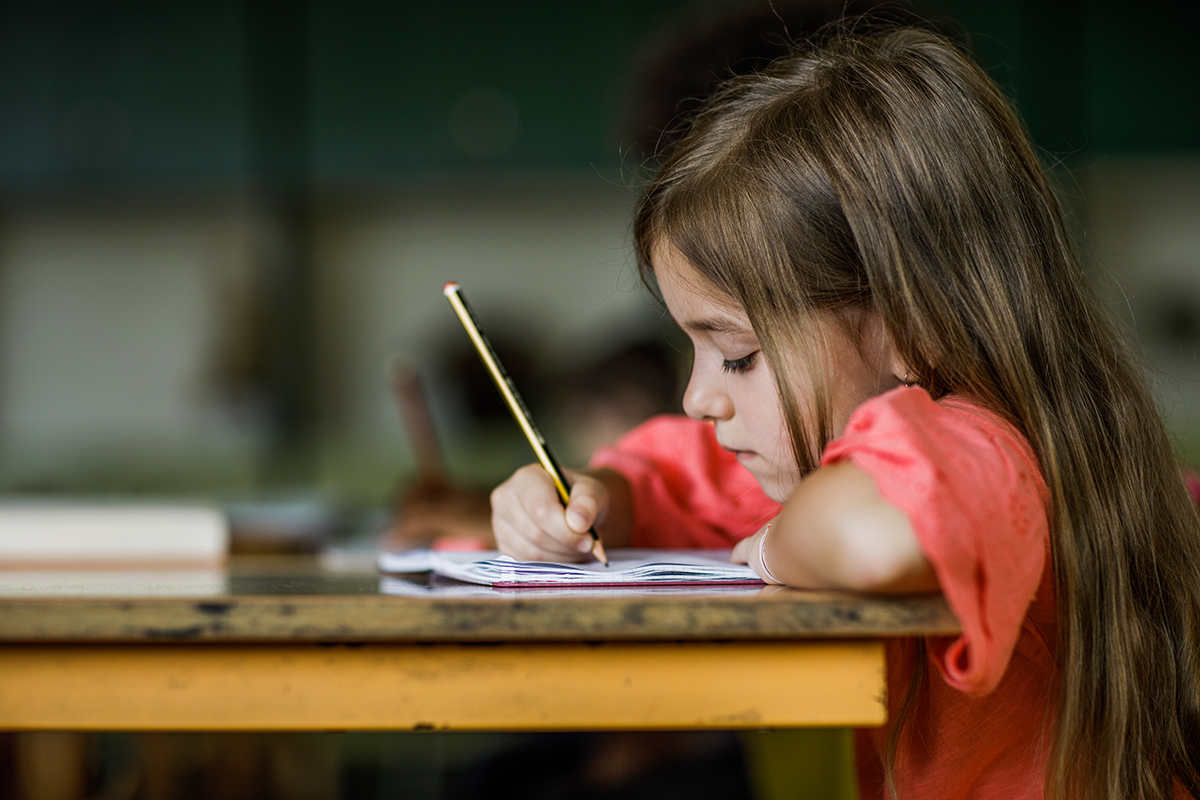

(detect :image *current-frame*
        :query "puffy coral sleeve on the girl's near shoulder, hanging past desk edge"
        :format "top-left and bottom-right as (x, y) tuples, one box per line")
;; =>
(822, 387), (1049, 694)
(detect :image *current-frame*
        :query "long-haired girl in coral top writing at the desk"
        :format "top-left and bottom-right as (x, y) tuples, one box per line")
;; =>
(492, 21), (1200, 798)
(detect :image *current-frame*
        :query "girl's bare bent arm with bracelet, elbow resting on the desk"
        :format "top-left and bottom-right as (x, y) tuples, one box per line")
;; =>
(733, 461), (938, 593)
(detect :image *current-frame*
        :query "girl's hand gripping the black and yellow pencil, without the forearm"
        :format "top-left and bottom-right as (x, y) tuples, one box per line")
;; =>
(492, 464), (610, 561)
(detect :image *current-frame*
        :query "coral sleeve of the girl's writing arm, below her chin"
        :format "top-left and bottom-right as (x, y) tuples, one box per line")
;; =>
(590, 415), (780, 548)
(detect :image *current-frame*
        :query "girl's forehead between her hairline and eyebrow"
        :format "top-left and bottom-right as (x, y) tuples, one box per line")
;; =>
(653, 245), (752, 333)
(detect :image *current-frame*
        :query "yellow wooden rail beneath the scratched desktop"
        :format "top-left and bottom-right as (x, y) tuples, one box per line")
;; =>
(0, 640), (886, 730)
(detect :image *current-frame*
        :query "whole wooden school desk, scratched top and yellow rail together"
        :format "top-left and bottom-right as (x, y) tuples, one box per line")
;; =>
(0, 559), (958, 730)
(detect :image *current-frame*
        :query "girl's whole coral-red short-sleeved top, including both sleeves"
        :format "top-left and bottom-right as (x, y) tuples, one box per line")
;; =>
(593, 387), (1056, 800)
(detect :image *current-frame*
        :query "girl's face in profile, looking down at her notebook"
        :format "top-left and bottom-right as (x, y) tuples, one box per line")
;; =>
(654, 246), (902, 503)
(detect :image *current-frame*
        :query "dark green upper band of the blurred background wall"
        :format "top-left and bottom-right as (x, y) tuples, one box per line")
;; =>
(0, 0), (1200, 192)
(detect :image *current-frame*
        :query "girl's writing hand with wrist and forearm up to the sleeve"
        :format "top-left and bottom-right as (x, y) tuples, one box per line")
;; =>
(492, 464), (634, 561)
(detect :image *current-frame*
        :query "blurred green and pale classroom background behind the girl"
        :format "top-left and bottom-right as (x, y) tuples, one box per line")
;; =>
(0, 0), (1200, 798)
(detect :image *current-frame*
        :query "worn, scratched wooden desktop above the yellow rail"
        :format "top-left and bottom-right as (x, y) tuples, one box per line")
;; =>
(0, 559), (959, 643)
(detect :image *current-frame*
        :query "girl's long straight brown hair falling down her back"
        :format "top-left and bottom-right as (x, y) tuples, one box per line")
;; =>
(635, 21), (1200, 798)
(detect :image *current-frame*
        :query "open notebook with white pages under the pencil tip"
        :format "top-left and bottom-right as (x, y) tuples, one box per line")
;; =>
(379, 549), (762, 589)
